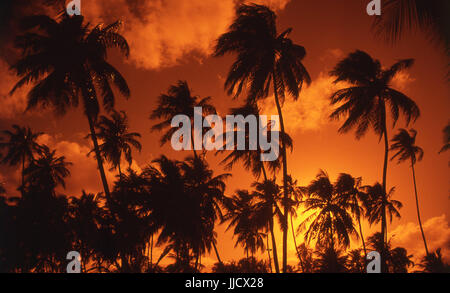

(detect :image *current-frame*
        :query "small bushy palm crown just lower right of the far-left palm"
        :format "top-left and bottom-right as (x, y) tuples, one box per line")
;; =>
(24, 146), (72, 193)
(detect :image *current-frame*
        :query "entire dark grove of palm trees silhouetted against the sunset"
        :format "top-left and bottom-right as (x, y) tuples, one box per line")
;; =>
(0, 0), (450, 273)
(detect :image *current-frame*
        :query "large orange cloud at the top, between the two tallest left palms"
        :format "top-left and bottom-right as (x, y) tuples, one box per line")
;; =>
(82, 0), (289, 69)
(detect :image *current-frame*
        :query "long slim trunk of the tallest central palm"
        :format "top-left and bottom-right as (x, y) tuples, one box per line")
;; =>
(273, 68), (289, 273)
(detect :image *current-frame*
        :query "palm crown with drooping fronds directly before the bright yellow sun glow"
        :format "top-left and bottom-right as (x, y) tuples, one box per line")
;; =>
(297, 171), (358, 249)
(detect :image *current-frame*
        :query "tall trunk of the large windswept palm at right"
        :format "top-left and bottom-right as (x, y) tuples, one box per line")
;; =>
(381, 105), (389, 272)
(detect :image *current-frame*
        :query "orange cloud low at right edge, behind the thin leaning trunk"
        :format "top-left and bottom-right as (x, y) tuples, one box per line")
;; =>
(389, 214), (450, 264)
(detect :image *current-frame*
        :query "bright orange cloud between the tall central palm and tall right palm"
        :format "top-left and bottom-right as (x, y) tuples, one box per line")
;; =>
(261, 73), (342, 133)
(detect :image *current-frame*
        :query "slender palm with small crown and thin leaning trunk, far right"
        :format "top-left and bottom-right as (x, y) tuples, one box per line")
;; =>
(390, 129), (428, 255)
